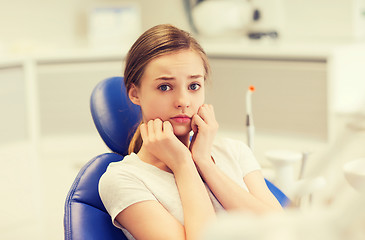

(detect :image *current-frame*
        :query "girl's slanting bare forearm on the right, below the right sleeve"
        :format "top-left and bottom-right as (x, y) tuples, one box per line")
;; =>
(199, 161), (281, 213)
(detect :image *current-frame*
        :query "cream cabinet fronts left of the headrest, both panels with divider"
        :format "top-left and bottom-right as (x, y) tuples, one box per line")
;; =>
(0, 54), (124, 149)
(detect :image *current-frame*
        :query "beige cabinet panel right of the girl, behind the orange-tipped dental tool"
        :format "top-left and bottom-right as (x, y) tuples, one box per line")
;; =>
(207, 56), (330, 140)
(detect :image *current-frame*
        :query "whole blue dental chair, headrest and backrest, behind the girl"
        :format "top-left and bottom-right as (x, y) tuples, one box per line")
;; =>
(64, 77), (289, 240)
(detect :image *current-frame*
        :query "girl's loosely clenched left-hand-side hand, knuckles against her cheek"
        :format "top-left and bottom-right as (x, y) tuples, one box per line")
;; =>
(140, 119), (191, 172)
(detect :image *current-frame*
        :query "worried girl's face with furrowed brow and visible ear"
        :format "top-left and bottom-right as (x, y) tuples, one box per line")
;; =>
(129, 50), (205, 136)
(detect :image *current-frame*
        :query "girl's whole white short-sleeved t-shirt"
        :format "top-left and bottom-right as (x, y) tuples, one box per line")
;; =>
(99, 138), (260, 239)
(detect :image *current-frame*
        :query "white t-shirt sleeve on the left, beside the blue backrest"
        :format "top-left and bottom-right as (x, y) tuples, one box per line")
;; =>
(99, 163), (156, 228)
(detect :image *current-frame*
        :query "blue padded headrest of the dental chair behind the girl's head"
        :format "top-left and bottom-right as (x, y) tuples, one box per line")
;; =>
(90, 77), (141, 156)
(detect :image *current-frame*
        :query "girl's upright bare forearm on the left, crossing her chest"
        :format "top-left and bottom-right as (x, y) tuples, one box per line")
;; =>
(174, 161), (215, 239)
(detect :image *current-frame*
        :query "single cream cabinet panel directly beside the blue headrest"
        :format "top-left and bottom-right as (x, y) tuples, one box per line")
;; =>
(37, 59), (123, 136)
